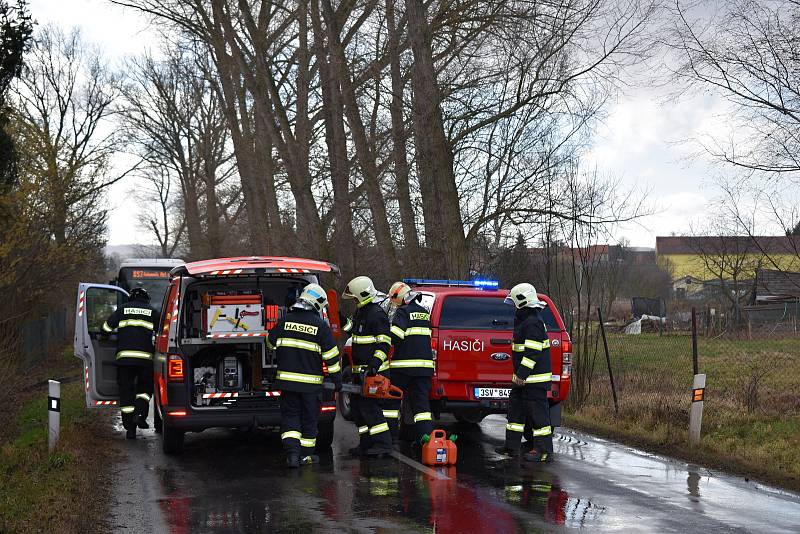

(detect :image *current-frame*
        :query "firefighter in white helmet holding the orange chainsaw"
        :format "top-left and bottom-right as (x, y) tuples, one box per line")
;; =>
(342, 276), (392, 456)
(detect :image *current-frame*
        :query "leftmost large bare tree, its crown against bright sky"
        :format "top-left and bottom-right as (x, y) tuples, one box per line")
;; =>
(12, 27), (132, 248)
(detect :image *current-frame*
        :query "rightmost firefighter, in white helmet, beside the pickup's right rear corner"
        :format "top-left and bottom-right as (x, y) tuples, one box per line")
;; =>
(496, 284), (553, 462)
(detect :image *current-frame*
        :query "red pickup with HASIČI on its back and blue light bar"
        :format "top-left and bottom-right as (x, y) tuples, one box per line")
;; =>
(340, 279), (572, 426)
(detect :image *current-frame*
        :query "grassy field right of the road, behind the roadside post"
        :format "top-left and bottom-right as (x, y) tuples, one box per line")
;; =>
(565, 334), (800, 490)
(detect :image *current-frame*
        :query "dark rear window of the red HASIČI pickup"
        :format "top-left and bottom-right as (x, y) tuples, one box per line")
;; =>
(439, 297), (561, 332)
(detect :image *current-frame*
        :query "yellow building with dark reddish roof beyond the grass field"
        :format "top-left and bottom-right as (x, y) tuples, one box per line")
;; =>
(656, 236), (800, 283)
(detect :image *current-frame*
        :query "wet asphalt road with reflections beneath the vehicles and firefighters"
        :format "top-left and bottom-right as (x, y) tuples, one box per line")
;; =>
(109, 416), (800, 534)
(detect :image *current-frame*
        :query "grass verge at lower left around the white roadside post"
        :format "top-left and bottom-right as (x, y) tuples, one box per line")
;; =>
(0, 355), (116, 533)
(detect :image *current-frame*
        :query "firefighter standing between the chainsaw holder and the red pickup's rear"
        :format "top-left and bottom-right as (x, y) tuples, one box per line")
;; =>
(389, 282), (433, 445)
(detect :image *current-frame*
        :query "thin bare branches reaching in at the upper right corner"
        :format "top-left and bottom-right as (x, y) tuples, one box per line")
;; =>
(672, 0), (800, 175)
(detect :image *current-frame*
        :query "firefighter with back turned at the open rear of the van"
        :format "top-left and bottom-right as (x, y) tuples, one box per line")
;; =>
(267, 284), (342, 467)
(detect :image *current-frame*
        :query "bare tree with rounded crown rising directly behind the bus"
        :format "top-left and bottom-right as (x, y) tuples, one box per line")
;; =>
(122, 46), (235, 257)
